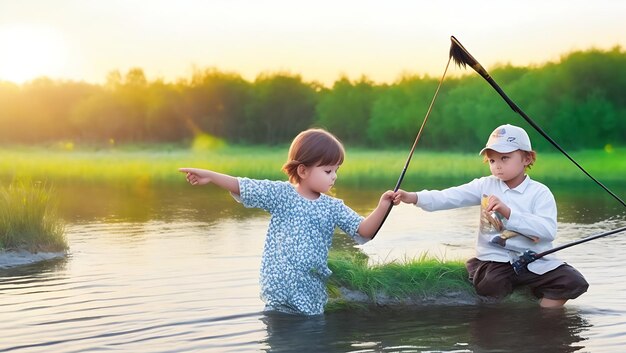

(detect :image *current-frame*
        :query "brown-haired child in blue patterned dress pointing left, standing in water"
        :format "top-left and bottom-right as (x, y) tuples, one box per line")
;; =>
(180, 129), (393, 315)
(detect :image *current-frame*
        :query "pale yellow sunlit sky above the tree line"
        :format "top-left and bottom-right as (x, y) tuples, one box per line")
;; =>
(0, 0), (626, 86)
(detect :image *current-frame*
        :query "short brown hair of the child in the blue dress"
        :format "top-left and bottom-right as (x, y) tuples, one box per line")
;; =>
(283, 129), (345, 184)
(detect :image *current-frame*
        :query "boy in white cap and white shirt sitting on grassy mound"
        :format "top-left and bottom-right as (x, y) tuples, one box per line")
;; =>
(394, 124), (589, 308)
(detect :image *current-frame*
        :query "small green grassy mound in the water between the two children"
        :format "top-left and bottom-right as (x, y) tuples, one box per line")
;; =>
(326, 251), (536, 312)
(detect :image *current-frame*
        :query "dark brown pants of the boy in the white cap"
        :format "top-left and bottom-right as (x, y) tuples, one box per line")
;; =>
(465, 258), (589, 300)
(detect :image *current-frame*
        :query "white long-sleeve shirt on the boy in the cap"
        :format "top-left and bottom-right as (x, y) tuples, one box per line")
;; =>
(416, 176), (563, 274)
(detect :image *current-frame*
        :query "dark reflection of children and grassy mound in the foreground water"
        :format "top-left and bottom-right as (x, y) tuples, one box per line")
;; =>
(261, 305), (591, 353)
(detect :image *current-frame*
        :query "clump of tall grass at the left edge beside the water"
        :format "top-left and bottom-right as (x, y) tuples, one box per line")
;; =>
(0, 181), (67, 252)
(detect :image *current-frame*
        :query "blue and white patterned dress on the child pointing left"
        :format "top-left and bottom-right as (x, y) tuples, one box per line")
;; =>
(238, 178), (363, 315)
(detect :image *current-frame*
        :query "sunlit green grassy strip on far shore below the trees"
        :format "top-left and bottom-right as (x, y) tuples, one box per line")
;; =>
(0, 146), (626, 186)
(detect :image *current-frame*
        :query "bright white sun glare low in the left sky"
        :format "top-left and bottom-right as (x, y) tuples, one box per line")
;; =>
(0, 25), (68, 84)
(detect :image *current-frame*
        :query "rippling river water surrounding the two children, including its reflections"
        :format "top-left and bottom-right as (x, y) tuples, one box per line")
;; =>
(0, 185), (626, 353)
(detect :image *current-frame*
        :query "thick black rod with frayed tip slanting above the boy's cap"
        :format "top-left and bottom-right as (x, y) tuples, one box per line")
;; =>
(450, 36), (626, 207)
